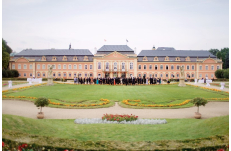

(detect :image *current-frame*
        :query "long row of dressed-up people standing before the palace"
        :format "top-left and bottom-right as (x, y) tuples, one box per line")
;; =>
(74, 77), (165, 85)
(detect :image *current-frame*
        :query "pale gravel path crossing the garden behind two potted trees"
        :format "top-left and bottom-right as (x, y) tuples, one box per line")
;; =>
(2, 100), (229, 119)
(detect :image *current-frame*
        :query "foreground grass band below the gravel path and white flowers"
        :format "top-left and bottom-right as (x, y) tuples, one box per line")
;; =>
(2, 114), (229, 142)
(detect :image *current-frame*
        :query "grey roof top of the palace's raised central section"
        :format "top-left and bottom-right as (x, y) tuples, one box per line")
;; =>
(98, 45), (134, 52)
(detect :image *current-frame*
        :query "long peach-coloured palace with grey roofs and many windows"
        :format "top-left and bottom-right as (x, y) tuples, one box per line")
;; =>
(9, 45), (222, 79)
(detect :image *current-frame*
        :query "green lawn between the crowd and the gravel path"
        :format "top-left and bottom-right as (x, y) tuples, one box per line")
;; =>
(2, 84), (228, 108)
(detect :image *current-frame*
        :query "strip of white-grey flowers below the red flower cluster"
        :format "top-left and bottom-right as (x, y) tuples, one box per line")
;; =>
(74, 118), (167, 124)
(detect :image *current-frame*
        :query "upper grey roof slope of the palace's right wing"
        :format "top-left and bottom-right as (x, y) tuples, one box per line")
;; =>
(138, 50), (216, 58)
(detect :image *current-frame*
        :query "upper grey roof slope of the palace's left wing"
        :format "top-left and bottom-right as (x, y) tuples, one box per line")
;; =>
(15, 49), (93, 57)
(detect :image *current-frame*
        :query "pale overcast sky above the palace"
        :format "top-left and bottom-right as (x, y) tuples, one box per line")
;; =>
(2, 0), (229, 53)
